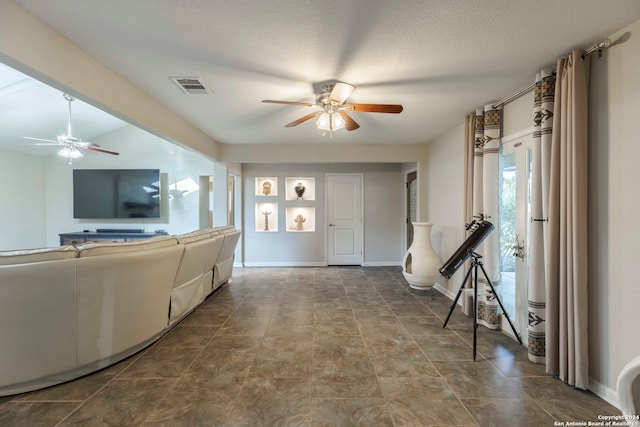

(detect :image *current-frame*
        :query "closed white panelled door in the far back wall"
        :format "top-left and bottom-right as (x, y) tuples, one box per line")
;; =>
(326, 174), (363, 265)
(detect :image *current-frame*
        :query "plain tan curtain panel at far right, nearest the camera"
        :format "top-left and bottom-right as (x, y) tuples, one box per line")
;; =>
(545, 50), (590, 390)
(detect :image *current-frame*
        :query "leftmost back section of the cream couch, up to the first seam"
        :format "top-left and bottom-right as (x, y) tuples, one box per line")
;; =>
(0, 259), (77, 395)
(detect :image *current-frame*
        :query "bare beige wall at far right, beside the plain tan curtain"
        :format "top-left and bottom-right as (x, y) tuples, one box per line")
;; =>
(589, 21), (640, 398)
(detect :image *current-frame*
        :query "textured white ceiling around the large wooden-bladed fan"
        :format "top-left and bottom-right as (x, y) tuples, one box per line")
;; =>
(3, 0), (640, 149)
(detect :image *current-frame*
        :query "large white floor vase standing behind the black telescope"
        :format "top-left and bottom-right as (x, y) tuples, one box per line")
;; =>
(402, 222), (442, 289)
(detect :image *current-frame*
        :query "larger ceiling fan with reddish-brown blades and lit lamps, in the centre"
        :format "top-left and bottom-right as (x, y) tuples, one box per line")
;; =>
(262, 82), (403, 133)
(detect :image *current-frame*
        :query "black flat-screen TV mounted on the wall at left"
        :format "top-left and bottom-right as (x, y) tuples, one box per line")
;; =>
(73, 169), (160, 219)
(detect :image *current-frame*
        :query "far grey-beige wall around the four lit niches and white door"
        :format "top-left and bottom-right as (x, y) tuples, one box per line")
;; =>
(243, 163), (405, 266)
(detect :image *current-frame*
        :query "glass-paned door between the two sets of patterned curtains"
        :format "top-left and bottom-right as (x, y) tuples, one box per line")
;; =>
(496, 135), (531, 342)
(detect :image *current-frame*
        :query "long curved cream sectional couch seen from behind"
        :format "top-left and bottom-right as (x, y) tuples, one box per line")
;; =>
(0, 227), (240, 396)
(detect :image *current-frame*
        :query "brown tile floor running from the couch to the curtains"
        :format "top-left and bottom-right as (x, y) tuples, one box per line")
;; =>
(0, 267), (620, 427)
